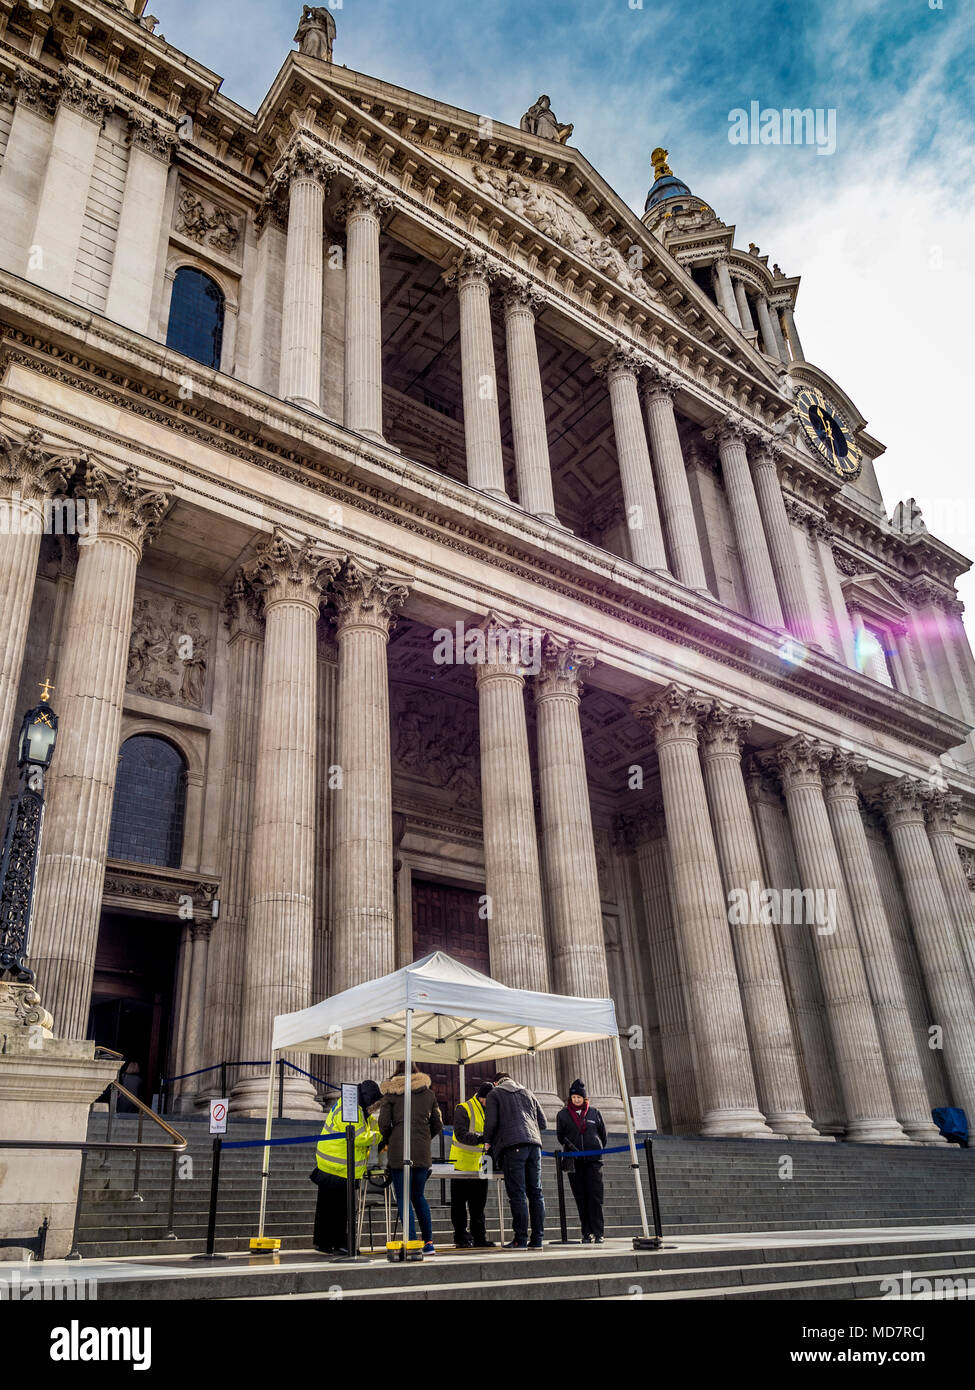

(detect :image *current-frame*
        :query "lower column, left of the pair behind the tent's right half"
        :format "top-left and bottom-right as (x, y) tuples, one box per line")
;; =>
(477, 614), (559, 1108)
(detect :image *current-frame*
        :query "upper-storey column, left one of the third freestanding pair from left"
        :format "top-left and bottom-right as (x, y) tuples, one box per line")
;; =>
(606, 353), (668, 570)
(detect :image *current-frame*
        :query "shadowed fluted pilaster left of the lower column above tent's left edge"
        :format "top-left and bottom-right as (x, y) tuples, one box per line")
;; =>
(200, 574), (264, 1095)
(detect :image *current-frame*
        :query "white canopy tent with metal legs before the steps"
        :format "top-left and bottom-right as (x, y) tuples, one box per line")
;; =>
(259, 951), (650, 1236)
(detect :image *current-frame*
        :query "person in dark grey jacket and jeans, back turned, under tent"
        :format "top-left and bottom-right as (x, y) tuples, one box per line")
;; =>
(484, 1072), (548, 1250)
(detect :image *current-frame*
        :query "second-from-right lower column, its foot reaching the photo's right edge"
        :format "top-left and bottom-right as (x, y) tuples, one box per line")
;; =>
(880, 777), (975, 1115)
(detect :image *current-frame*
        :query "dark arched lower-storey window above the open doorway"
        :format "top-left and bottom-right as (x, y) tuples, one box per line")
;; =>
(108, 734), (186, 869)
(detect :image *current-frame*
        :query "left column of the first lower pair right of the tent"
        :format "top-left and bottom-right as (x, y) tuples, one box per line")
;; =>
(633, 685), (772, 1138)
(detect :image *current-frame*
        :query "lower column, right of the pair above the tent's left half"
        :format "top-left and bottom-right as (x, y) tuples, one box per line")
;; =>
(331, 560), (409, 994)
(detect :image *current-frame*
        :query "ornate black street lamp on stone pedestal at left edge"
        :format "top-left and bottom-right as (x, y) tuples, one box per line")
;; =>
(0, 681), (57, 984)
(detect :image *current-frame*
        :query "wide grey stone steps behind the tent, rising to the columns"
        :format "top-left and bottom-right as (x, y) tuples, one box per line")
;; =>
(79, 1113), (975, 1262)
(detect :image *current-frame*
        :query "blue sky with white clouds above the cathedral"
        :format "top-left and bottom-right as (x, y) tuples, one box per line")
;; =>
(149, 0), (975, 608)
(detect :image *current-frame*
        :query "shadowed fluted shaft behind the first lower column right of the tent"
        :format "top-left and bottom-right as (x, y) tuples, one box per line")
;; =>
(636, 806), (701, 1134)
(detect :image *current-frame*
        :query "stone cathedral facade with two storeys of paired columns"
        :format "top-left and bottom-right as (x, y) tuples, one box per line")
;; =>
(0, 0), (975, 1143)
